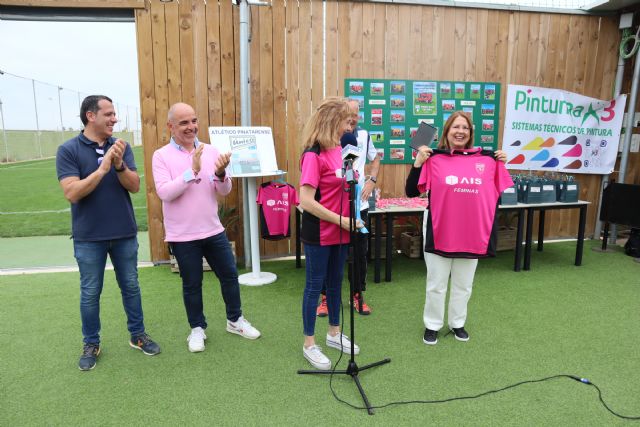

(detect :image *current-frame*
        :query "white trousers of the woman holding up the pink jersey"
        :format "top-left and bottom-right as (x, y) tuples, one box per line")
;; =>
(422, 211), (478, 331)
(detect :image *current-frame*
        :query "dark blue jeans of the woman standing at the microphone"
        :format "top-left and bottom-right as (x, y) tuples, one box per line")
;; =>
(302, 243), (349, 337)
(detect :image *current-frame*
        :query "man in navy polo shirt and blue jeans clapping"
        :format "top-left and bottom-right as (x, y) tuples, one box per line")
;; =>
(56, 95), (160, 371)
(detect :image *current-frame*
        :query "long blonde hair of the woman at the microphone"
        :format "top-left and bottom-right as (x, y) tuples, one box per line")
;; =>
(302, 96), (353, 150)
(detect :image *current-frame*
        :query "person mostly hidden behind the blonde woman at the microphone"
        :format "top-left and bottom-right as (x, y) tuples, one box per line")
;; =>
(316, 99), (380, 317)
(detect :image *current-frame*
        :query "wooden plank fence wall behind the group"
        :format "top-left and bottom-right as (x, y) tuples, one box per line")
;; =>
(136, 0), (620, 260)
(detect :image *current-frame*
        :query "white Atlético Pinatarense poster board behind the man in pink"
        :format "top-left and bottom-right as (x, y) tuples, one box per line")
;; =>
(209, 126), (278, 177)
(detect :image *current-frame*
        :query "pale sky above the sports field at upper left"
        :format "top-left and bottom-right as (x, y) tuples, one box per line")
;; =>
(0, 20), (139, 129)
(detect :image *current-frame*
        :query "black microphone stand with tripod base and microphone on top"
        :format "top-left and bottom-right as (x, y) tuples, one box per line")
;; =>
(298, 158), (391, 415)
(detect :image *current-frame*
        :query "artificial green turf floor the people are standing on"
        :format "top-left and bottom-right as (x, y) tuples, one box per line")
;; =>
(0, 242), (640, 426)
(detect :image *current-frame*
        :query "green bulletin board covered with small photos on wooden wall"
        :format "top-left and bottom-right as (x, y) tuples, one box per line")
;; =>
(344, 79), (500, 164)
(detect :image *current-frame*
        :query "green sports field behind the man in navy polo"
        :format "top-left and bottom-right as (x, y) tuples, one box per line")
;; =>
(0, 143), (147, 237)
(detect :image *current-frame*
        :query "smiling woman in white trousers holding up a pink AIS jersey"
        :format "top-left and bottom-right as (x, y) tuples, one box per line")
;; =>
(405, 111), (513, 345)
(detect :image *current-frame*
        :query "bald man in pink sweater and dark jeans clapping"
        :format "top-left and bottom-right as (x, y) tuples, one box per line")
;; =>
(153, 103), (260, 353)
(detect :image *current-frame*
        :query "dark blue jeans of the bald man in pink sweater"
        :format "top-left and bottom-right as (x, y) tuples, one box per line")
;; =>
(170, 232), (242, 329)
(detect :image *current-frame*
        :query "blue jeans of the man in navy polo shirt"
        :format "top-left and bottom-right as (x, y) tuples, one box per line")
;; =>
(73, 237), (144, 344)
